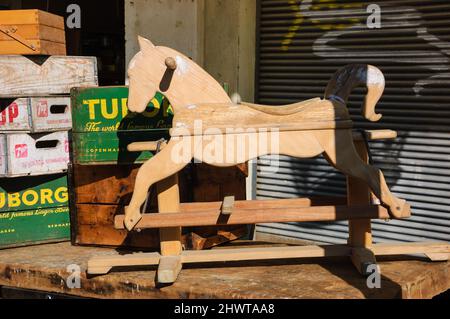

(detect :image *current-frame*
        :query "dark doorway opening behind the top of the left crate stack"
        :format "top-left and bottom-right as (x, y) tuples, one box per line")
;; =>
(0, 0), (125, 86)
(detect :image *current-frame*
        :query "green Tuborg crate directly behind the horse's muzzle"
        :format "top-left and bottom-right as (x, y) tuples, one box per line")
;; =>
(71, 86), (173, 165)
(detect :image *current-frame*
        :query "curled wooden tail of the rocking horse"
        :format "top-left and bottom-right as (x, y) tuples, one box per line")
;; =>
(325, 64), (385, 122)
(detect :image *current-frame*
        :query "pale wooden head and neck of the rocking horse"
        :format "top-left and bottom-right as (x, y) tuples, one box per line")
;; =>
(128, 37), (231, 113)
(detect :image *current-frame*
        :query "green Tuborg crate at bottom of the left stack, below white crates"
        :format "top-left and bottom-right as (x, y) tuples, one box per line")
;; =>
(0, 175), (70, 249)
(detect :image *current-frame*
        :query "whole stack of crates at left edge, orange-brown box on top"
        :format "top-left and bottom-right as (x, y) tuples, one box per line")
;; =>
(0, 10), (98, 248)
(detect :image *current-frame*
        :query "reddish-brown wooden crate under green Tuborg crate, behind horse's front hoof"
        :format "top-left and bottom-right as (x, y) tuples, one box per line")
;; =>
(70, 165), (159, 249)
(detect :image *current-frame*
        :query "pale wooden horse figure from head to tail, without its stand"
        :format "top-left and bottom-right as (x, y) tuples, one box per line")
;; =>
(125, 38), (409, 230)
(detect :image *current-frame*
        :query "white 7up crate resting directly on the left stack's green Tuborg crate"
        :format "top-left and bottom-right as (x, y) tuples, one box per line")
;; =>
(0, 132), (70, 177)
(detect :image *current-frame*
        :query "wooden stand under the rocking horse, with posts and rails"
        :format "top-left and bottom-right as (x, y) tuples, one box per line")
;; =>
(87, 131), (450, 284)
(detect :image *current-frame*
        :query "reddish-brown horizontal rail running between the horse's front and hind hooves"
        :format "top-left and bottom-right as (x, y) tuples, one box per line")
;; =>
(115, 204), (389, 229)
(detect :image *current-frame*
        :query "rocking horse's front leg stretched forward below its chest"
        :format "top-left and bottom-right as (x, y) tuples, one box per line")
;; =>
(124, 141), (192, 231)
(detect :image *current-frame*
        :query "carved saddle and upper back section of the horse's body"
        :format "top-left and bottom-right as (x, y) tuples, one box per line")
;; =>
(170, 98), (352, 136)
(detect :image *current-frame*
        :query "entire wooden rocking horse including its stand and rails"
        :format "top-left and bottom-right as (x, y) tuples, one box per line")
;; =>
(88, 37), (450, 283)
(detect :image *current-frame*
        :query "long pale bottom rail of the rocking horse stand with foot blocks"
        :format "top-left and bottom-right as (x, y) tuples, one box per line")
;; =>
(88, 242), (450, 284)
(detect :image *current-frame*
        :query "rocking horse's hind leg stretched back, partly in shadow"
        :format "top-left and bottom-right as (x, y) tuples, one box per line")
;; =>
(322, 130), (410, 218)
